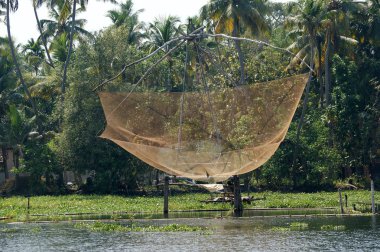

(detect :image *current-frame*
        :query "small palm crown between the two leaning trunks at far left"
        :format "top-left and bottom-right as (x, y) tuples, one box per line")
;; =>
(22, 38), (45, 76)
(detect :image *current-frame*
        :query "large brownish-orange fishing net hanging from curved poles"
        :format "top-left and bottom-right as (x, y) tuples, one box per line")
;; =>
(100, 75), (307, 181)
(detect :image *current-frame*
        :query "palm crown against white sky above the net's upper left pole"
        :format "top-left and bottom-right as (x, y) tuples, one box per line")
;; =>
(107, 0), (145, 45)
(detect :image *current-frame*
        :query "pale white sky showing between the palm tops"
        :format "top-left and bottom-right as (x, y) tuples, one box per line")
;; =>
(0, 0), (284, 44)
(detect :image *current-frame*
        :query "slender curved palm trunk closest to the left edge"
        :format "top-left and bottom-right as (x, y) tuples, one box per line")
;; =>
(1, 0), (38, 117)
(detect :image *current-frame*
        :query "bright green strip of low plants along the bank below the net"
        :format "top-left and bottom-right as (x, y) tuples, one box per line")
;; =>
(0, 191), (380, 221)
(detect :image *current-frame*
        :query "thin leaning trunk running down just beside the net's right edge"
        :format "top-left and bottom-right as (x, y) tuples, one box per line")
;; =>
(292, 44), (314, 169)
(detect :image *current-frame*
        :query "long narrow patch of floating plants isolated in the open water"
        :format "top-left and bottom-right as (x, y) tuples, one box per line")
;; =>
(74, 221), (210, 234)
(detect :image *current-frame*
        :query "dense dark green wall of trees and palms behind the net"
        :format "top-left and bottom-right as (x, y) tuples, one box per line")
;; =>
(0, 0), (380, 193)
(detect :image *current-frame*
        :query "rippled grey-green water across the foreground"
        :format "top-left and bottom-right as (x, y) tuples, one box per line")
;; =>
(0, 216), (380, 252)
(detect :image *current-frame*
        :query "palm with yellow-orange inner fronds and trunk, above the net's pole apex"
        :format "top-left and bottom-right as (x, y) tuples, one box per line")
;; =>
(200, 0), (269, 84)
